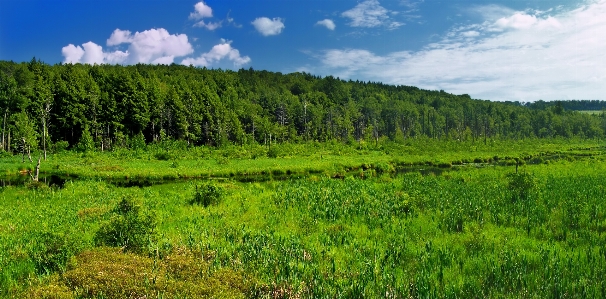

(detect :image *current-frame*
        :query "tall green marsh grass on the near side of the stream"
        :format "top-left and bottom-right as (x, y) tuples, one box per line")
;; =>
(0, 145), (606, 298)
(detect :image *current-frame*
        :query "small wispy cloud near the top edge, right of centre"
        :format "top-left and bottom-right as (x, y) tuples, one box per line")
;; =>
(341, 0), (404, 29)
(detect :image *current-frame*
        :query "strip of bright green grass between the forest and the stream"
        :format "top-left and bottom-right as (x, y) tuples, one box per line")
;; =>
(0, 139), (602, 181)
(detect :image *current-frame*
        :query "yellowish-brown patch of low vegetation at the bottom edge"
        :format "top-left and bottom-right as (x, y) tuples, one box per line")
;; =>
(27, 247), (263, 298)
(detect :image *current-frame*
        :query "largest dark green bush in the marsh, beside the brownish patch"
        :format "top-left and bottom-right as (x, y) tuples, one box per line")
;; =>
(95, 197), (156, 253)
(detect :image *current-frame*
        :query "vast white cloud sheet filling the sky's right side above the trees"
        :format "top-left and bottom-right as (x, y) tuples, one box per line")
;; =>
(308, 0), (606, 101)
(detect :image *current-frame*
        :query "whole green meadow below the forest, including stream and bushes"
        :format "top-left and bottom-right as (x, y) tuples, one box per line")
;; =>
(0, 139), (606, 298)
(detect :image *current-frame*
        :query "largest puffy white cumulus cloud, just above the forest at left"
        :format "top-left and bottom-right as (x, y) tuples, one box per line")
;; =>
(62, 28), (193, 64)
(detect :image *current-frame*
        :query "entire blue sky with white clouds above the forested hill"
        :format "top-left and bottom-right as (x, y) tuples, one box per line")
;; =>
(0, 0), (606, 102)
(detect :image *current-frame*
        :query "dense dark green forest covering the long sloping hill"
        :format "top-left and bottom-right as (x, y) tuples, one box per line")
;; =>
(0, 59), (606, 151)
